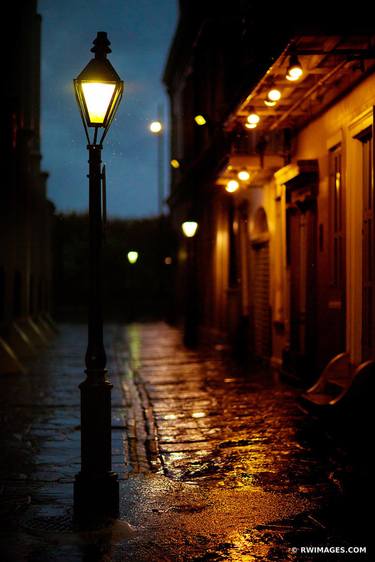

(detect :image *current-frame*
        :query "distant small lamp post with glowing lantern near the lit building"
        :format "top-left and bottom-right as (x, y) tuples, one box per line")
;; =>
(181, 216), (198, 347)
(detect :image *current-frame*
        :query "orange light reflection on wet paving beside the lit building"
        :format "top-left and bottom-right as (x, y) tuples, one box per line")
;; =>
(119, 327), (328, 492)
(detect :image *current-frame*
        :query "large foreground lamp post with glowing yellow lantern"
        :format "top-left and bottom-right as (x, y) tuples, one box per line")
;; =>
(74, 31), (124, 521)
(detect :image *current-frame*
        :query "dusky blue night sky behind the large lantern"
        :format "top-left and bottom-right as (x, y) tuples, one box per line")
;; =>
(38, 0), (178, 217)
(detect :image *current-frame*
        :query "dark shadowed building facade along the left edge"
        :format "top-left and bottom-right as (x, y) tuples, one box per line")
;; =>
(0, 1), (54, 371)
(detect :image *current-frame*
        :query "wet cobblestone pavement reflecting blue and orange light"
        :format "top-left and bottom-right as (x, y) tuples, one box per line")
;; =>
(0, 324), (371, 562)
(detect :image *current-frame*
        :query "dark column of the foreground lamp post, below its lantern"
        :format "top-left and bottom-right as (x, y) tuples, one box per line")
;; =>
(74, 140), (119, 520)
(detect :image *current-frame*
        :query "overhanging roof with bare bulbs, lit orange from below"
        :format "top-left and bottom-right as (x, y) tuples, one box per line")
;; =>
(225, 34), (375, 132)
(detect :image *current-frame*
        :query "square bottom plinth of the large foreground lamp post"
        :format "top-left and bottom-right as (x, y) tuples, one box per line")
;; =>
(74, 472), (120, 526)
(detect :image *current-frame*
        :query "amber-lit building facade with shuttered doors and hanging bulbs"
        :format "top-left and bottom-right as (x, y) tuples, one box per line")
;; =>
(165, 2), (375, 384)
